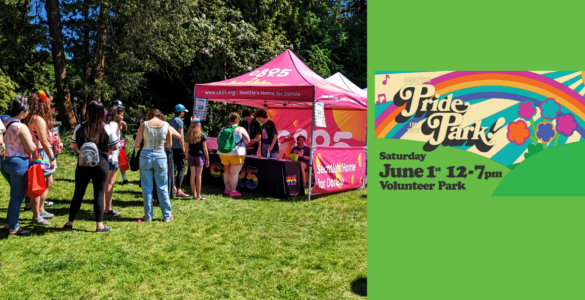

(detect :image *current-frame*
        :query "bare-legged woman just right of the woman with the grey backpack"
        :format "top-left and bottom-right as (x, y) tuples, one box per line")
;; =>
(104, 107), (124, 216)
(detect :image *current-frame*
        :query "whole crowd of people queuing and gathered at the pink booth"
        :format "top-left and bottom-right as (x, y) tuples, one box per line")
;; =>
(0, 89), (310, 235)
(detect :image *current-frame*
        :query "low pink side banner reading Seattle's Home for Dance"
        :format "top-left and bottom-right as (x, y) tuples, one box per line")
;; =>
(311, 147), (366, 194)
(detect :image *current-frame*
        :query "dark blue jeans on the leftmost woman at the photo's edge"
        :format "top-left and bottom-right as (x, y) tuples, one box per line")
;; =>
(0, 156), (29, 229)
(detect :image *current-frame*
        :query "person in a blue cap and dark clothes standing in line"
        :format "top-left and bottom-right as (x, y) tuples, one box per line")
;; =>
(169, 104), (190, 198)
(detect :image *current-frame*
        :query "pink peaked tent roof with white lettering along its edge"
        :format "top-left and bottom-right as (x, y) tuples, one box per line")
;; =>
(194, 50), (367, 110)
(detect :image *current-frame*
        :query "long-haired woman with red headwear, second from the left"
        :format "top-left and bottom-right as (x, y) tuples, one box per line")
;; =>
(23, 90), (57, 225)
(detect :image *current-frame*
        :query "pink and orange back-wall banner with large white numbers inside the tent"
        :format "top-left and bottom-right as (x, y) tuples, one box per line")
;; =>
(268, 108), (367, 155)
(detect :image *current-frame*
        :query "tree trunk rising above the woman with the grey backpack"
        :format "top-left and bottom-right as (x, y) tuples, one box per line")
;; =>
(90, 1), (110, 102)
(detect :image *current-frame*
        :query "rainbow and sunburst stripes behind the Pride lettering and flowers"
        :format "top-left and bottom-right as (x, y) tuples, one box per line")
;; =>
(375, 71), (585, 166)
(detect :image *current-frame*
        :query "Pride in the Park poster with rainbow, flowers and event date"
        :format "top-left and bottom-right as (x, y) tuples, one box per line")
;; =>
(371, 71), (585, 196)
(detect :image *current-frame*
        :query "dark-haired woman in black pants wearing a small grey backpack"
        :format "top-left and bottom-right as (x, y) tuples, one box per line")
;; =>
(63, 101), (119, 232)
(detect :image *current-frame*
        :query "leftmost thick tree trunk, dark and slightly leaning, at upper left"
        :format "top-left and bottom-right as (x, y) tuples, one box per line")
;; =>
(45, 0), (77, 127)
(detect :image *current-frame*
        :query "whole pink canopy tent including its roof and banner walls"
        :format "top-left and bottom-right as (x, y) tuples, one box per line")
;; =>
(194, 50), (367, 199)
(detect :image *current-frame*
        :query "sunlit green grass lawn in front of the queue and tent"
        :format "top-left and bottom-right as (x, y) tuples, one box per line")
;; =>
(0, 156), (367, 299)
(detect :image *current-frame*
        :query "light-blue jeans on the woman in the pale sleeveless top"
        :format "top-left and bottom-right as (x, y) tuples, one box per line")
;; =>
(139, 149), (172, 220)
